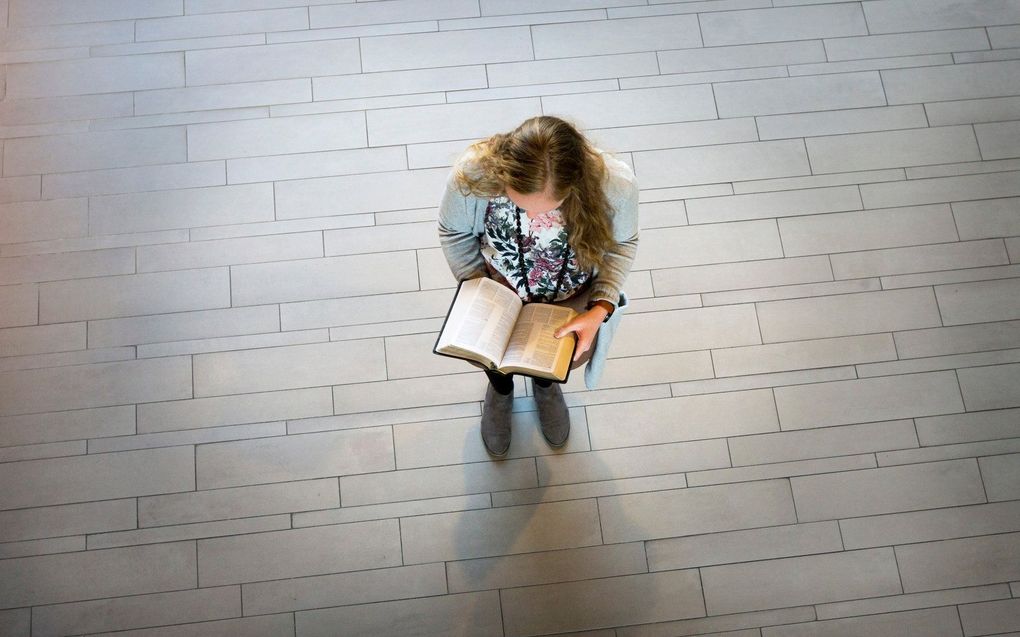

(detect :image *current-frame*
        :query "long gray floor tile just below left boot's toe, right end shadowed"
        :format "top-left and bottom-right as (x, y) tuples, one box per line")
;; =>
(340, 458), (538, 507)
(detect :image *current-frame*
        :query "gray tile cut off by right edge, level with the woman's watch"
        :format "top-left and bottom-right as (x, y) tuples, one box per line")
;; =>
(935, 278), (1020, 325)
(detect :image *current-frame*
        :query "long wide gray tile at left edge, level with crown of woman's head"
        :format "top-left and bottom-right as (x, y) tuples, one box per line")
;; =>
(3, 127), (187, 176)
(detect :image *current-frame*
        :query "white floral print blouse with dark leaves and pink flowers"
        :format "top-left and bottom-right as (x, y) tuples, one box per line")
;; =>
(481, 195), (592, 302)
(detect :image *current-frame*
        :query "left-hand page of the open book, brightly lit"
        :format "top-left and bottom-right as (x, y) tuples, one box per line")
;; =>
(437, 278), (521, 363)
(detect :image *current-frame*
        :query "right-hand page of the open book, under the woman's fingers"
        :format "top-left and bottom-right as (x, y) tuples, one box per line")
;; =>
(501, 303), (577, 378)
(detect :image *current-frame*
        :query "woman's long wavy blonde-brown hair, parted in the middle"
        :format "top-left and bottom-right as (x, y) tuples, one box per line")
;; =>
(455, 115), (613, 270)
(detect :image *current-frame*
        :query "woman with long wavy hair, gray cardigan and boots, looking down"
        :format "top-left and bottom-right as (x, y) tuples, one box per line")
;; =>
(440, 116), (638, 457)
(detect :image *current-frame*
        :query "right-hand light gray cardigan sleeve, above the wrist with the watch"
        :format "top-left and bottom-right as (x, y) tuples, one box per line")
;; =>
(591, 159), (638, 307)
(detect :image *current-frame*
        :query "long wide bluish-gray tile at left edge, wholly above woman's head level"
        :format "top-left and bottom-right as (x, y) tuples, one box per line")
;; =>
(6, 52), (185, 99)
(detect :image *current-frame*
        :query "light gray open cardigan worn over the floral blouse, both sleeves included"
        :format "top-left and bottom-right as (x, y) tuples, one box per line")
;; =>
(440, 154), (638, 389)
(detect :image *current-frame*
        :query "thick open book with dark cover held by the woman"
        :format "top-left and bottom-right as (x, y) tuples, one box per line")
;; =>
(432, 277), (577, 382)
